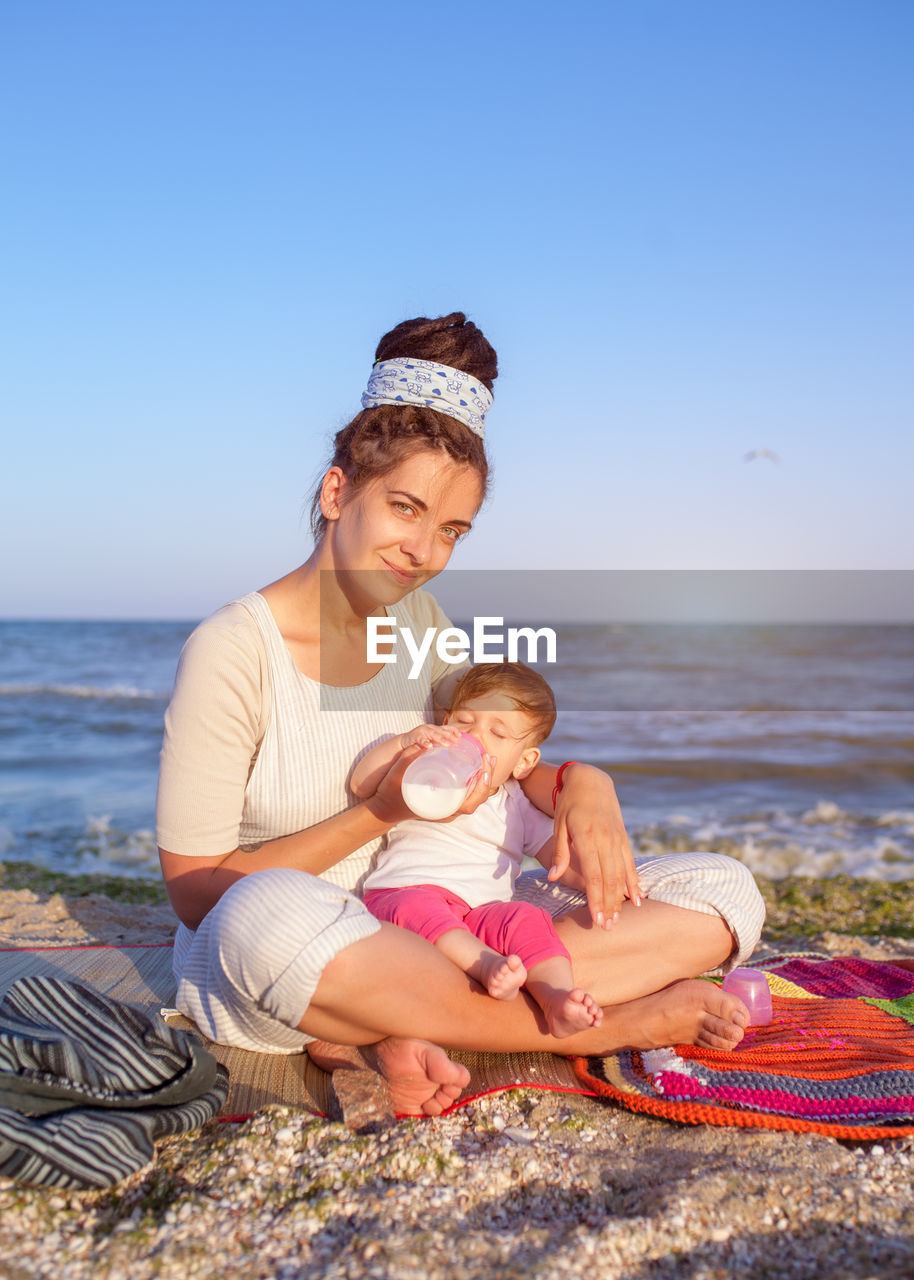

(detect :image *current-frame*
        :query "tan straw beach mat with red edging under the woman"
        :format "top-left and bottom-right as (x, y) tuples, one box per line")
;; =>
(0, 943), (594, 1119)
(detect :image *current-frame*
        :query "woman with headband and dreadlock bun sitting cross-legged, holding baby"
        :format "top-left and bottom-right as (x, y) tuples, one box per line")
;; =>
(157, 312), (763, 1115)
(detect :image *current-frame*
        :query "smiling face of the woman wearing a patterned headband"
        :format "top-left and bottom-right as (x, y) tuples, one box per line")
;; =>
(324, 449), (481, 604)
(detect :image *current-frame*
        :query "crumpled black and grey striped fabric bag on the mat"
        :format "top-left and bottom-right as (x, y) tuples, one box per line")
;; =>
(0, 977), (228, 1188)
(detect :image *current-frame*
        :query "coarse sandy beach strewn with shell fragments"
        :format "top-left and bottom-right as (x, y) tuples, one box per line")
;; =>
(0, 874), (914, 1280)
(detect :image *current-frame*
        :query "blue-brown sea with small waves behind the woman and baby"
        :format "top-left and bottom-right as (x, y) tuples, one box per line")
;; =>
(0, 621), (914, 882)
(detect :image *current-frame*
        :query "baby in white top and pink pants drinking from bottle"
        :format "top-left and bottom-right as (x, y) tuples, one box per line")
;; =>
(351, 662), (603, 1036)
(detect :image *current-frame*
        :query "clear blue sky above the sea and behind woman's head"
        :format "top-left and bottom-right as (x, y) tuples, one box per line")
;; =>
(0, 0), (914, 618)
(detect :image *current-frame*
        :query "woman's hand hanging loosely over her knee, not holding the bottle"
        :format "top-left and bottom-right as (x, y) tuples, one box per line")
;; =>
(549, 764), (641, 928)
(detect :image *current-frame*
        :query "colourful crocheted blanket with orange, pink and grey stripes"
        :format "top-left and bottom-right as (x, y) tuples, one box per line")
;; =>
(575, 954), (914, 1140)
